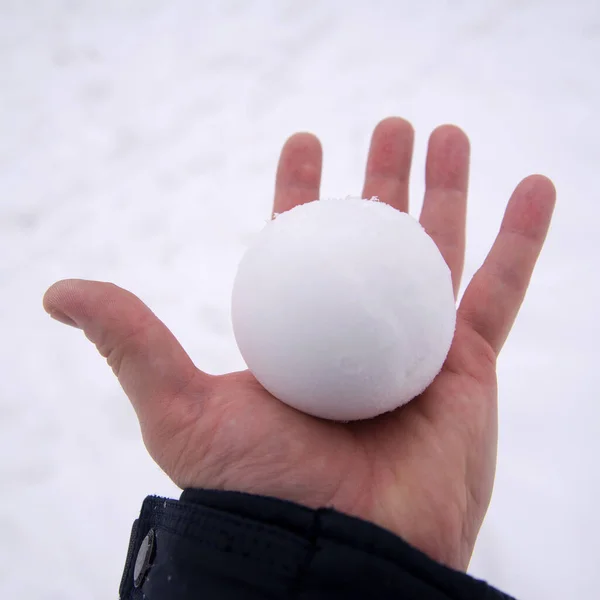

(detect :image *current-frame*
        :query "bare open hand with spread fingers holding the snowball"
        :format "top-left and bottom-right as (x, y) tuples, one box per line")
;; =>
(44, 118), (555, 569)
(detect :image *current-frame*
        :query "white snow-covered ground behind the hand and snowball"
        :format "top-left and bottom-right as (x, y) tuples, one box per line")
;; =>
(0, 0), (600, 600)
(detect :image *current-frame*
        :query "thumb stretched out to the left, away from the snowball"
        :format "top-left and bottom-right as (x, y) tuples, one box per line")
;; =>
(44, 279), (207, 421)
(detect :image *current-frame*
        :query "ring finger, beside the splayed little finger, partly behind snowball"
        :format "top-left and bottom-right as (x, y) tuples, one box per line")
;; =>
(420, 125), (469, 296)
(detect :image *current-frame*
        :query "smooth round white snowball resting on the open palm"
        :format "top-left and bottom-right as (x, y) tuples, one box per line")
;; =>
(232, 198), (456, 421)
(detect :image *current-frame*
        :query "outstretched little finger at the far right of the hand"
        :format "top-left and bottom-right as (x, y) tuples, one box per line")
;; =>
(459, 175), (556, 353)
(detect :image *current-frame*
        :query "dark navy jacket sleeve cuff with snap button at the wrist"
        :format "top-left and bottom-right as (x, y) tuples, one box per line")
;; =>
(120, 490), (510, 600)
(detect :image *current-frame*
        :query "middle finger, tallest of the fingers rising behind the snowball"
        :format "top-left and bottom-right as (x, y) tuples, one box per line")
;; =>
(363, 117), (414, 212)
